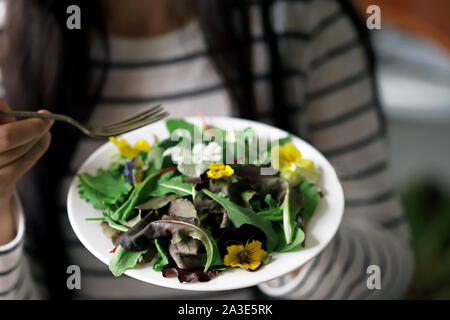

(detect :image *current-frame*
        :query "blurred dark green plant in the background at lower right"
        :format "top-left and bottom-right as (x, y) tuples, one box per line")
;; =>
(402, 182), (450, 299)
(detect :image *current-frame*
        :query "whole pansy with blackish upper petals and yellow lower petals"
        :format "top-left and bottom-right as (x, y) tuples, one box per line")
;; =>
(218, 224), (267, 271)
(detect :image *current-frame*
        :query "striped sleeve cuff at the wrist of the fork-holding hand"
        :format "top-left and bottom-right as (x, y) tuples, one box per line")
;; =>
(0, 195), (39, 300)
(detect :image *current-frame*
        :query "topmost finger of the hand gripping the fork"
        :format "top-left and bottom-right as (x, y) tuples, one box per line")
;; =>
(0, 118), (54, 152)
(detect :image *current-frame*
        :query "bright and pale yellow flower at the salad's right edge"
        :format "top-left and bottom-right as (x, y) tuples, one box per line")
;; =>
(271, 143), (319, 185)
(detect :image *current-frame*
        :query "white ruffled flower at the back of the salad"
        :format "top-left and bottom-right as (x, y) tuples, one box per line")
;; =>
(163, 142), (222, 178)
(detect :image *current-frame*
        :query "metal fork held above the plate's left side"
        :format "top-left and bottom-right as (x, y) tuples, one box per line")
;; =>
(0, 105), (169, 138)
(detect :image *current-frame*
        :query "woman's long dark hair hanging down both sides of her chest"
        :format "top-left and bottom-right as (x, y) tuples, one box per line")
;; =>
(0, 0), (372, 298)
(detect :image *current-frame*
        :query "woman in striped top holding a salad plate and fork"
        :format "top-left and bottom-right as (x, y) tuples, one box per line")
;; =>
(0, 0), (412, 299)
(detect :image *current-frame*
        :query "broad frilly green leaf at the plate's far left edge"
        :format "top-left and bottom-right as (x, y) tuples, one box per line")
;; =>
(78, 169), (133, 209)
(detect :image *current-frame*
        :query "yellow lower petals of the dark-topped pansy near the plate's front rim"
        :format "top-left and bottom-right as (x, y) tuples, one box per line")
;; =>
(223, 240), (267, 271)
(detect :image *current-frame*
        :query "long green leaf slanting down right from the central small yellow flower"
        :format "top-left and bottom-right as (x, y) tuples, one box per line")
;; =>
(203, 189), (278, 251)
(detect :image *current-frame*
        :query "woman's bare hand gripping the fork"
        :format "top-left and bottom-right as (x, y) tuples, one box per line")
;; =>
(0, 99), (54, 245)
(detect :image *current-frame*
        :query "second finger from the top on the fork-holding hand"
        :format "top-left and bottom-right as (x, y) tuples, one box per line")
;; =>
(0, 132), (51, 189)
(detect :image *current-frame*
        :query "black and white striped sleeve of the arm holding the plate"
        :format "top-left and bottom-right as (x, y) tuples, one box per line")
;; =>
(260, 1), (413, 299)
